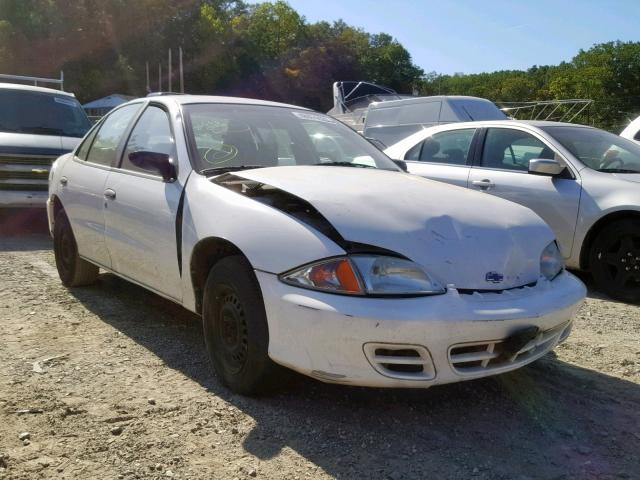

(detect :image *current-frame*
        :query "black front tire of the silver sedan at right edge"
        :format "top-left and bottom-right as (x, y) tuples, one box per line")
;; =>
(589, 220), (640, 302)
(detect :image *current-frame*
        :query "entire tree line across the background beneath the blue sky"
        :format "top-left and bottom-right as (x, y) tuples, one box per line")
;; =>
(0, 0), (640, 131)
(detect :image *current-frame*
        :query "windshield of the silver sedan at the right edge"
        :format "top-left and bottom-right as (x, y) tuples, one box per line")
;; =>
(542, 127), (640, 173)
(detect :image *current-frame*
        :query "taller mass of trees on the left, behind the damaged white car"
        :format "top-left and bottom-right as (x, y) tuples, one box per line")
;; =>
(0, 0), (423, 110)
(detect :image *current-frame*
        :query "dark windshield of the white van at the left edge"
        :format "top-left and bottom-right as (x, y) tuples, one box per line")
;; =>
(0, 89), (91, 137)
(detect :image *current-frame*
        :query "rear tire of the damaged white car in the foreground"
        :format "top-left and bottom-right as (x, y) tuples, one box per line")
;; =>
(53, 210), (99, 287)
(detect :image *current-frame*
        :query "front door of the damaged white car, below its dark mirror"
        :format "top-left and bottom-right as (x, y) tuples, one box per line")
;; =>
(105, 104), (188, 300)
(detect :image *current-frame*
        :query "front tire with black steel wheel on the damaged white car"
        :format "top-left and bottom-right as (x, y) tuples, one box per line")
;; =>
(202, 255), (286, 395)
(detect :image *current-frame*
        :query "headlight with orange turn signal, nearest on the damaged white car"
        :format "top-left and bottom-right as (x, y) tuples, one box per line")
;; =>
(280, 255), (445, 296)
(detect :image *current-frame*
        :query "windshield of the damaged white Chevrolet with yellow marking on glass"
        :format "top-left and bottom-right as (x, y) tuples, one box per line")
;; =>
(184, 103), (398, 173)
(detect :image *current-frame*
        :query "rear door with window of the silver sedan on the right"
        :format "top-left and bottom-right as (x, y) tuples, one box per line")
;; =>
(404, 128), (476, 187)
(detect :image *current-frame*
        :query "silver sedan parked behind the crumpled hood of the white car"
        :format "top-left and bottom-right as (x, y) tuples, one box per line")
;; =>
(385, 120), (640, 301)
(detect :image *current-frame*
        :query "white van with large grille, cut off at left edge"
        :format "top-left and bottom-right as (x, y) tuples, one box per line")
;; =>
(0, 83), (91, 208)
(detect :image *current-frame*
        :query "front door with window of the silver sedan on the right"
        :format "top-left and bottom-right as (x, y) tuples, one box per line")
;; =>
(469, 127), (582, 258)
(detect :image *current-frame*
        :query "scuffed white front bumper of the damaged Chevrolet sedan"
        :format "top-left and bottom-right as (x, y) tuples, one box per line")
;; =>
(256, 272), (586, 388)
